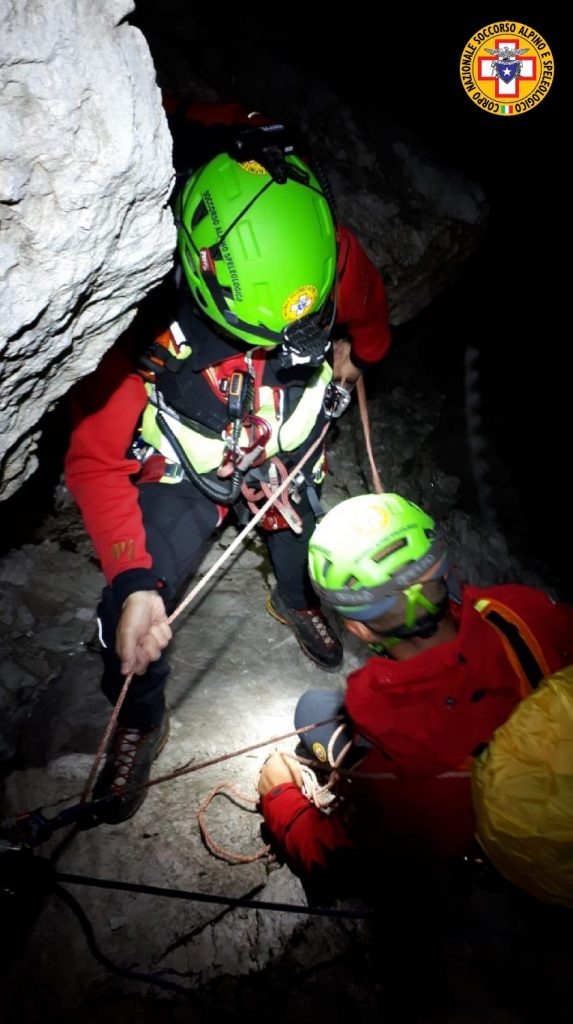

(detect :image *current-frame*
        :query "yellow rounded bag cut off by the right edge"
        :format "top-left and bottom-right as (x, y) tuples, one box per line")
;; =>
(472, 666), (573, 907)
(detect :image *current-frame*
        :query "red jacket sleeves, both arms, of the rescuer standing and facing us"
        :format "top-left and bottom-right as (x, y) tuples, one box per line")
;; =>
(65, 227), (390, 589)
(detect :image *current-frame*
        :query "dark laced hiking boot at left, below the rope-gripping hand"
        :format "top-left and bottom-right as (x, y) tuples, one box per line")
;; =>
(93, 714), (169, 825)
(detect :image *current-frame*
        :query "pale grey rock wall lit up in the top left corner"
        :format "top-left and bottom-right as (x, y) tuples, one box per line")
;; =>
(0, 0), (175, 498)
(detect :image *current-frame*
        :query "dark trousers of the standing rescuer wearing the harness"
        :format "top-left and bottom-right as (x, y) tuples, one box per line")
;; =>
(97, 480), (317, 729)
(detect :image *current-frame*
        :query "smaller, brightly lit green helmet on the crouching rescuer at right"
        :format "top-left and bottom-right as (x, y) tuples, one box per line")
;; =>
(308, 495), (447, 632)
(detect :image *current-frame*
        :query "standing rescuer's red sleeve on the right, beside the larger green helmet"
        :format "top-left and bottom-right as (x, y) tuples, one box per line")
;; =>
(337, 226), (390, 370)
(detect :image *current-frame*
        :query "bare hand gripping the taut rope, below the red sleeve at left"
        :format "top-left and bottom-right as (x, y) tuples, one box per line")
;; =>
(116, 590), (171, 676)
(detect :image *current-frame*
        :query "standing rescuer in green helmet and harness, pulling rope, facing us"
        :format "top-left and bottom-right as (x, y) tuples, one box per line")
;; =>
(67, 109), (389, 821)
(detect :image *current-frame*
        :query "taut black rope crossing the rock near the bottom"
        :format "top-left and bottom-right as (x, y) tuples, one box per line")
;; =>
(55, 872), (373, 921)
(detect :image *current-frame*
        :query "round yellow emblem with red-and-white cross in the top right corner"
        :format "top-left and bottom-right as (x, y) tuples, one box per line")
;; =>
(459, 22), (554, 116)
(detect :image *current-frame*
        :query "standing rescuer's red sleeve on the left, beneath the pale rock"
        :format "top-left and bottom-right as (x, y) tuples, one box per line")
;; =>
(64, 349), (151, 583)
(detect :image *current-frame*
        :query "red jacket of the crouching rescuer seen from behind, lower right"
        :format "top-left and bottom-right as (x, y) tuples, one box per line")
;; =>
(261, 585), (573, 874)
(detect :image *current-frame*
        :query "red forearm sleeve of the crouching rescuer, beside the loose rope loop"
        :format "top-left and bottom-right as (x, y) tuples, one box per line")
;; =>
(261, 782), (354, 876)
